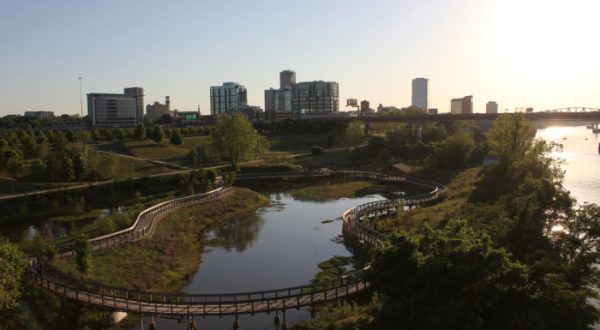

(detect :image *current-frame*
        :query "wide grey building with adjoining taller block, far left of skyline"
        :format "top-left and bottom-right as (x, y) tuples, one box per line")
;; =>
(87, 87), (144, 127)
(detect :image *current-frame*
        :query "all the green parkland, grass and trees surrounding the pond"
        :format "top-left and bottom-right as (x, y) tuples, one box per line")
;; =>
(0, 115), (600, 330)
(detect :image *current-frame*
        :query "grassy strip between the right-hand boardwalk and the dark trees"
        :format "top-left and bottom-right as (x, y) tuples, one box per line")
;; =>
(374, 168), (479, 233)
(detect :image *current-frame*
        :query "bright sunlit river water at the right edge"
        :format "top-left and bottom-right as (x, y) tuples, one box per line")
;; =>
(536, 126), (600, 204)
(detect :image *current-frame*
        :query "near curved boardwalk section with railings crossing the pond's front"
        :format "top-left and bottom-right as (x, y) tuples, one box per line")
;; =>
(28, 256), (368, 315)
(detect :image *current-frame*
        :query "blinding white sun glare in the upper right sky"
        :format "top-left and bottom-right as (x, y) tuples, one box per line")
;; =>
(490, 0), (600, 90)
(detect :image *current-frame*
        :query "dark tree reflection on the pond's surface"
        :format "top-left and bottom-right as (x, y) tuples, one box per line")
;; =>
(213, 212), (265, 252)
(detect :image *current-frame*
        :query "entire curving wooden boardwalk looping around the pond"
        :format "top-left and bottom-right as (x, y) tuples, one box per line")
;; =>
(28, 170), (444, 329)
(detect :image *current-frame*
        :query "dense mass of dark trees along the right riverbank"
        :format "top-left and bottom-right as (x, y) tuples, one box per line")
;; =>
(362, 115), (600, 329)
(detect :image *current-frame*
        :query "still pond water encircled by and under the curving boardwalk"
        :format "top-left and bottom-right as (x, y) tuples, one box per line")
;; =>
(144, 191), (390, 330)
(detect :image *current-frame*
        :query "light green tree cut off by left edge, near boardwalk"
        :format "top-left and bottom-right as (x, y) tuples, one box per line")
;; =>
(0, 237), (26, 314)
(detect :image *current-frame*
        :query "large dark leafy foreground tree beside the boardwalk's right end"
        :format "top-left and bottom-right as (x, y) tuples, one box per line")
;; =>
(368, 220), (528, 329)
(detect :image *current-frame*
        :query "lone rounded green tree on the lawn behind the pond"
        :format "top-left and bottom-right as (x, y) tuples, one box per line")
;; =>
(211, 112), (268, 170)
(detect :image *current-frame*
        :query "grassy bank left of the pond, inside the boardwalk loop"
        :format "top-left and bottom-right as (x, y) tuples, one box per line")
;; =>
(55, 188), (268, 292)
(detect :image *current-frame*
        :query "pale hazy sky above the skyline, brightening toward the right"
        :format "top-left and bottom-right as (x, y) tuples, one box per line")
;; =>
(0, 0), (600, 115)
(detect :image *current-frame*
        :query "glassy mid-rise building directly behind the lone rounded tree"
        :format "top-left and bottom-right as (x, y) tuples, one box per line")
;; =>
(210, 82), (248, 116)
